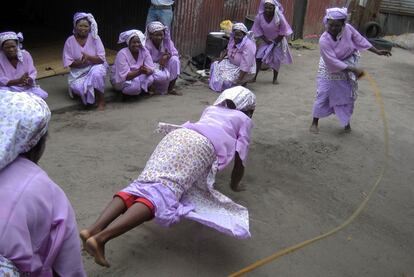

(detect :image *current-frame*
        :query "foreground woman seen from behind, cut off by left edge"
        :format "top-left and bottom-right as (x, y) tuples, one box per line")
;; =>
(0, 90), (86, 276)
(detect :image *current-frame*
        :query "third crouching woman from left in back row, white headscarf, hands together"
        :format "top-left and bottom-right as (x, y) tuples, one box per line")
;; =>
(111, 30), (155, 95)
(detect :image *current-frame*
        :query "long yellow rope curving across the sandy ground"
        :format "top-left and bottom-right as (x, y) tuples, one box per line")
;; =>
(229, 73), (389, 277)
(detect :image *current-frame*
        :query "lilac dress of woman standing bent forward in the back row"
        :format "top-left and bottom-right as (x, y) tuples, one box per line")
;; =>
(252, 11), (292, 71)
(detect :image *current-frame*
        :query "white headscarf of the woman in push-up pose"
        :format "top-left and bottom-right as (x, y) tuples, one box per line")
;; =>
(213, 86), (256, 111)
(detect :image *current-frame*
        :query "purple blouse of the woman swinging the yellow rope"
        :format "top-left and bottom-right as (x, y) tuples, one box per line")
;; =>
(319, 24), (372, 73)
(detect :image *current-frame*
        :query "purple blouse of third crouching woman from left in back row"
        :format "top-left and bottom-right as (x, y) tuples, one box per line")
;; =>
(111, 47), (155, 84)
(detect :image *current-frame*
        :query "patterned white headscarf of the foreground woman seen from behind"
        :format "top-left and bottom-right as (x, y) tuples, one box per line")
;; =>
(0, 90), (50, 170)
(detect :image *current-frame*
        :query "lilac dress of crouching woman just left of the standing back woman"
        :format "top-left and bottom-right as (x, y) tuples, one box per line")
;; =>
(209, 35), (256, 92)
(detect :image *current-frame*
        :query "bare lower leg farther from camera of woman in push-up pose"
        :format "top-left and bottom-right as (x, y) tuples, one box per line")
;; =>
(79, 197), (127, 248)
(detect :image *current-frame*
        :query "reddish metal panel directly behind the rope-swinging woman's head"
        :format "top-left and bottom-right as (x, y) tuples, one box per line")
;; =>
(303, 0), (347, 36)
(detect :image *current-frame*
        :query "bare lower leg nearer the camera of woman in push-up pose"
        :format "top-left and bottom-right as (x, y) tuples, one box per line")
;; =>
(86, 203), (152, 267)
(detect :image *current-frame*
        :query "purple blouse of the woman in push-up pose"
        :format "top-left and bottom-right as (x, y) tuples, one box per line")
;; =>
(182, 106), (253, 170)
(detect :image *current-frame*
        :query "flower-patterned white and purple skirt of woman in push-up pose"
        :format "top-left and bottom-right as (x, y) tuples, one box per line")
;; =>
(122, 128), (250, 238)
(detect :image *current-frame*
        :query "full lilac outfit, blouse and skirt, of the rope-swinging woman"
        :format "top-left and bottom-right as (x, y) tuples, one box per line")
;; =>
(313, 24), (372, 126)
